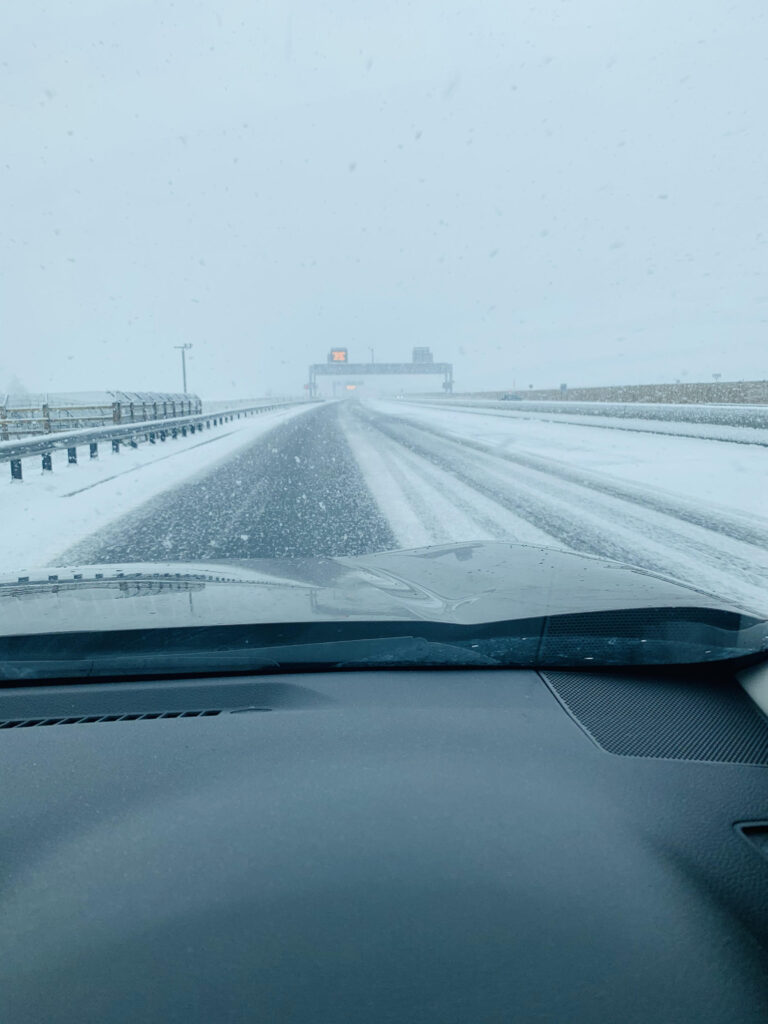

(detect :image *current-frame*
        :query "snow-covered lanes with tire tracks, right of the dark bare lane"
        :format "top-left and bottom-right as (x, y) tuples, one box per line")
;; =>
(342, 401), (768, 613)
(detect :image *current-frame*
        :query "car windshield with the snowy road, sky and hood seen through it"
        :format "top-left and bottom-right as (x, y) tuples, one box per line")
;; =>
(0, 0), (768, 675)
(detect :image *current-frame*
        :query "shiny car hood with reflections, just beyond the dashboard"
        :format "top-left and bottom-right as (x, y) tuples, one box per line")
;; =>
(0, 541), (749, 636)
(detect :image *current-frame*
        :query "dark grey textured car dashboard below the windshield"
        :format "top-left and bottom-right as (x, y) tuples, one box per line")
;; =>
(0, 668), (768, 1024)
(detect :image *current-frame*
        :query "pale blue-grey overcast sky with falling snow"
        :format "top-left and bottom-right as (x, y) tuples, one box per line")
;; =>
(0, 0), (768, 397)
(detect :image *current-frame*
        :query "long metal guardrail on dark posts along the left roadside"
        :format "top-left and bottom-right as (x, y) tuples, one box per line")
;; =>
(0, 398), (316, 481)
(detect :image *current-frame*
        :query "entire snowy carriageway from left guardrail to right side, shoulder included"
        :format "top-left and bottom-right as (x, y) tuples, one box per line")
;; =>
(3, 400), (768, 615)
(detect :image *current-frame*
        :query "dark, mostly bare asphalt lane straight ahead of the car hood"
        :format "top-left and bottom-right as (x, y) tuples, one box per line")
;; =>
(61, 403), (397, 564)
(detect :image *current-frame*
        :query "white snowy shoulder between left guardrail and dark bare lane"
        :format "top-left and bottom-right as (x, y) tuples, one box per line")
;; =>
(0, 406), (316, 571)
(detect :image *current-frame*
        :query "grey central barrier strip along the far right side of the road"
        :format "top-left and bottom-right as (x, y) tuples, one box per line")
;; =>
(404, 395), (768, 429)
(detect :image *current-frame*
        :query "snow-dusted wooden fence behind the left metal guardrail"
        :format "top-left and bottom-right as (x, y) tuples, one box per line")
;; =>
(0, 391), (202, 441)
